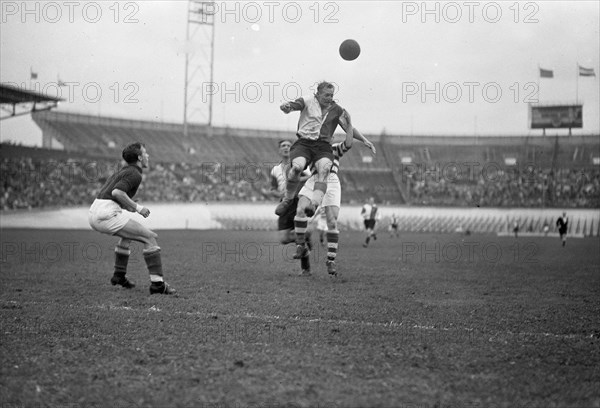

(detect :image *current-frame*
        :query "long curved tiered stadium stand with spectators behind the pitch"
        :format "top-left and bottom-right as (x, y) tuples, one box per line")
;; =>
(0, 111), (600, 215)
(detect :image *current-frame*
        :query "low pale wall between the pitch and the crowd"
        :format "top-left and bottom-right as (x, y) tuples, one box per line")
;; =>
(0, 203), (600, 237)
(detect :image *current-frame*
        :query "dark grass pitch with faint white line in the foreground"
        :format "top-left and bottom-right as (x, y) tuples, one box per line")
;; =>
(0, 230), (600, 408)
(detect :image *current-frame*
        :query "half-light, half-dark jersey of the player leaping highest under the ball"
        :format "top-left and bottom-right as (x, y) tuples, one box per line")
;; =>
(290, 95), (344, 143)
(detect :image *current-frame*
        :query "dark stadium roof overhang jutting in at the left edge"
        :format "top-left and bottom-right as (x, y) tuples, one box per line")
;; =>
(0, 84), (64, 120)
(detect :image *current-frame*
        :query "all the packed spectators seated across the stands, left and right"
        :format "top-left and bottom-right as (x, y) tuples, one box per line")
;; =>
(0, 157), (600, 210)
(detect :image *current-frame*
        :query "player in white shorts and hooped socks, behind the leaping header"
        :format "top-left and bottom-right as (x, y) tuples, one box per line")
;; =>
(294, 112), (376, 276)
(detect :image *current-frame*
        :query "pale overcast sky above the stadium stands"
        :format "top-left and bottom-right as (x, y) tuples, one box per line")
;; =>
(0, 0), (600, 145)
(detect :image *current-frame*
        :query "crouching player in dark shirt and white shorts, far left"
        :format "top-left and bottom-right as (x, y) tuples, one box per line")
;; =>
(88, 143), (175, 295)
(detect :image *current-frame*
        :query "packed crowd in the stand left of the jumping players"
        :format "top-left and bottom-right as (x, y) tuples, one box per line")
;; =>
(0, 157), (268, 210)
